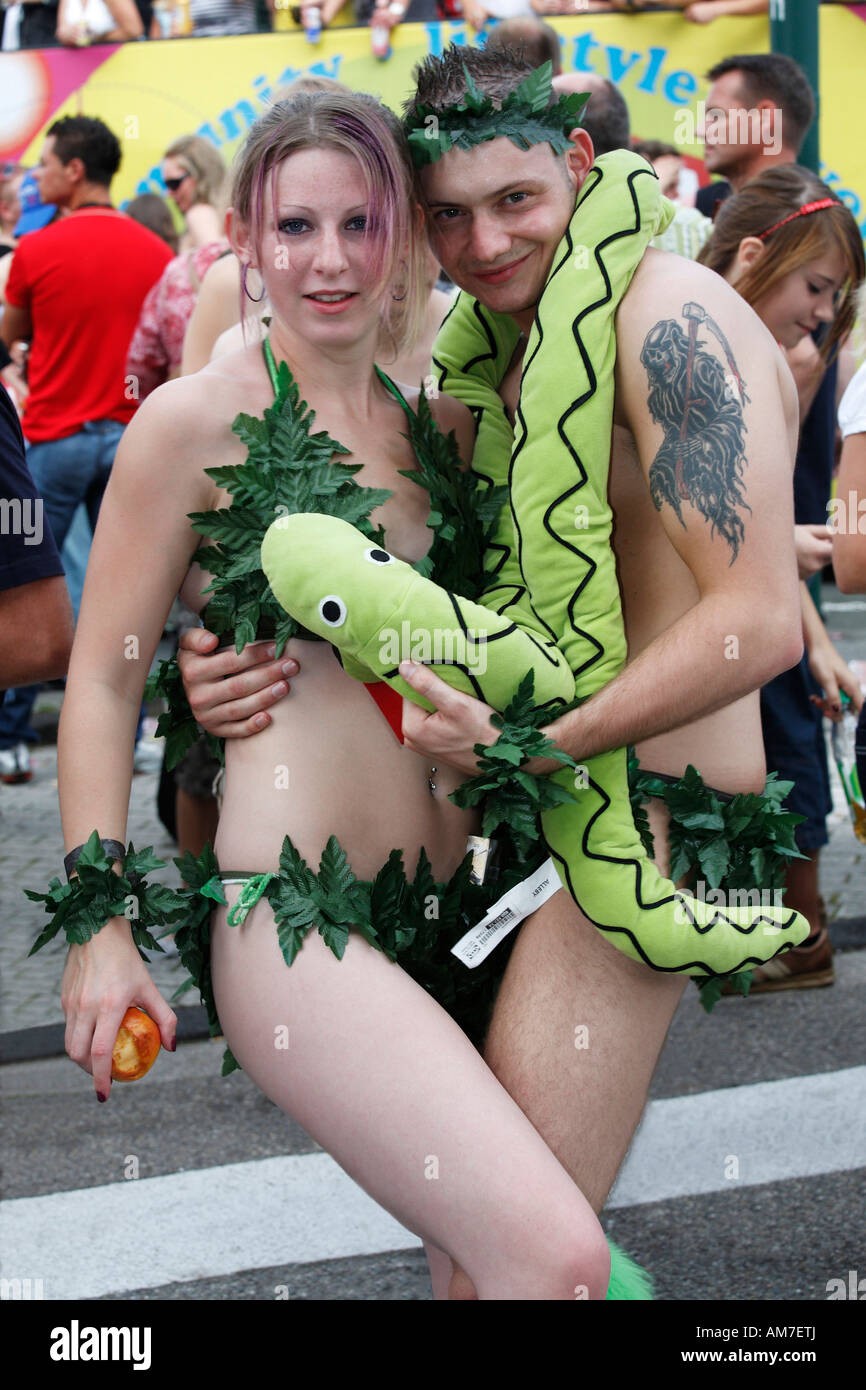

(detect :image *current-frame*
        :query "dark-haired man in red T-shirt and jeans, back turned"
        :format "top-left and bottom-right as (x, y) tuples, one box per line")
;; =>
(0, 115), (171, 783)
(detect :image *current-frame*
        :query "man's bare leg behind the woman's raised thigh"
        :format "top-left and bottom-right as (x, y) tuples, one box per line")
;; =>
(485, 802), (687, 1211)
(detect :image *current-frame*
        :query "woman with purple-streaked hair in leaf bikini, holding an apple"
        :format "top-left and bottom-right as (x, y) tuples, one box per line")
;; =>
(60, 93), (609, 1300)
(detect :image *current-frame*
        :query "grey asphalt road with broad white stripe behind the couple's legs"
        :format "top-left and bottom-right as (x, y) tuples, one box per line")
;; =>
(0, 591), (866, 1304)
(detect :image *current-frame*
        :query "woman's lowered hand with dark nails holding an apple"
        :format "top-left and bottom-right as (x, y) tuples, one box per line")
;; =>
(60, 917), (178, 1101)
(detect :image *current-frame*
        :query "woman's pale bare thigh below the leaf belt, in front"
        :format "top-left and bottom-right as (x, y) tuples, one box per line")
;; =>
(211, 888), (609, 1300)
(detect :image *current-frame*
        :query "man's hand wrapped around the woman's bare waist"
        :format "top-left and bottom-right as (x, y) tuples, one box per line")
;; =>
(178, 627), (300, 738)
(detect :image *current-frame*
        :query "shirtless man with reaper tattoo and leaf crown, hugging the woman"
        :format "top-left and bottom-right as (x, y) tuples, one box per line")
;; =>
(182, 49), (802, 1273)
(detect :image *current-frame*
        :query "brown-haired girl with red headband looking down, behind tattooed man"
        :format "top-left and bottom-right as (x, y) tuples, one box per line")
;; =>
(698, 164), (865, 992)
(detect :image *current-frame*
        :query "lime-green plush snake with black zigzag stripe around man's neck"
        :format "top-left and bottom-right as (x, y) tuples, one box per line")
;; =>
(261, 138), (809, 976)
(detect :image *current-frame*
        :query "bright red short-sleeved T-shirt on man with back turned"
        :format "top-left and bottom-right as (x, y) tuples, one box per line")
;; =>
(6, 207), (171, 443)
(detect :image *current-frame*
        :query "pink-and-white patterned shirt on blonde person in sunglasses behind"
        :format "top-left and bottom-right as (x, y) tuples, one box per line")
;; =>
(126, 240), (228, 400)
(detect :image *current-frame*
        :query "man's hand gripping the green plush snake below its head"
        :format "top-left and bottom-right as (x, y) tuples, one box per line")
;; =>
(400, 662), (499, 777)
